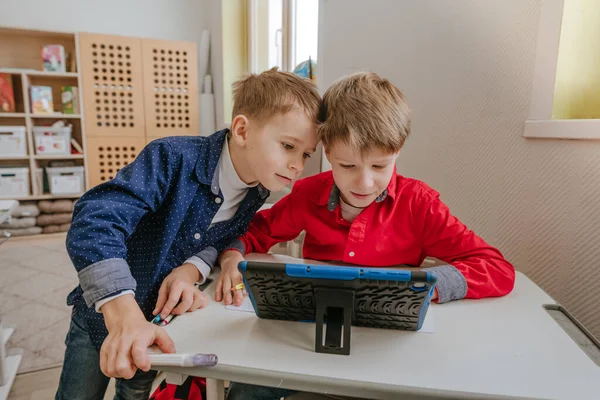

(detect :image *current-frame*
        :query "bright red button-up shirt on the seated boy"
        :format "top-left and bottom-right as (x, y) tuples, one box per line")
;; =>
(241, 171), (515, 298)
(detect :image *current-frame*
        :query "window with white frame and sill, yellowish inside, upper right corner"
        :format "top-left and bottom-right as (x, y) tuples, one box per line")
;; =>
(524, 0), (600, 139)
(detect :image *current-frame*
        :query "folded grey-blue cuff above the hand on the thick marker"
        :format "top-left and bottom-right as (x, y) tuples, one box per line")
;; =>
(77, 258), (136, 307)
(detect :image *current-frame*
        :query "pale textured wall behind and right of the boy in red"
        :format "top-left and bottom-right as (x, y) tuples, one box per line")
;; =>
(319, 0), (600, 336)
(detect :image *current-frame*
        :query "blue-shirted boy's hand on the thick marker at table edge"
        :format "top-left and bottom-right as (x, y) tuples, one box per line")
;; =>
(100, 295), (175, 379)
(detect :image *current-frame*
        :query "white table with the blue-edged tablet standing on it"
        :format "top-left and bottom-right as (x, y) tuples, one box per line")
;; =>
(165, 256), (600, 399)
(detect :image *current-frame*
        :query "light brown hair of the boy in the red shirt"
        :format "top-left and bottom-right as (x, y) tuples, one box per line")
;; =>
(319, 72), (411, 154)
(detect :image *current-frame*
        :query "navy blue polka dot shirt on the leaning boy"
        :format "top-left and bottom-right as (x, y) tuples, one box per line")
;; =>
(67, 130), (269, 349)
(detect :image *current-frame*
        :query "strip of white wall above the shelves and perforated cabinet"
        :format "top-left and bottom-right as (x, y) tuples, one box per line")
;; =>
(0, 0), (207, 41)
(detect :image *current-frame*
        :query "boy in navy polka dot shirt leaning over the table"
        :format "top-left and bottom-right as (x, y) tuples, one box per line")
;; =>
(56, 70), (320, 400)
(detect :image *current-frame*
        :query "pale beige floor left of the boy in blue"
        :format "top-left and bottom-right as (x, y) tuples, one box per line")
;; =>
(0, 234), (77, 373)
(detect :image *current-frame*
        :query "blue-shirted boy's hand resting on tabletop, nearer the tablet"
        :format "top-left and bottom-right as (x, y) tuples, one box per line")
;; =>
(152, 264), (209, 319)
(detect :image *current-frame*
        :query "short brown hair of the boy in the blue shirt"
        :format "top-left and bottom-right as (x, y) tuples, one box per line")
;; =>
(232, 67), (321, 123)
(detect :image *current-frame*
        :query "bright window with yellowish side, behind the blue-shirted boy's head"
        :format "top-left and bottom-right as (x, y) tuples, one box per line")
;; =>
(221, 0), (319, 124)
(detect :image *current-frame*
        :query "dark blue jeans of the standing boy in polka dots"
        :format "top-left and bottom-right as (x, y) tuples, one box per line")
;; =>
(55, 309), (156, 400)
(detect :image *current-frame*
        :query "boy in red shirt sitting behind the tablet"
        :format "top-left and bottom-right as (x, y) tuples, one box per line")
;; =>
(216, 73), (515, 400)
